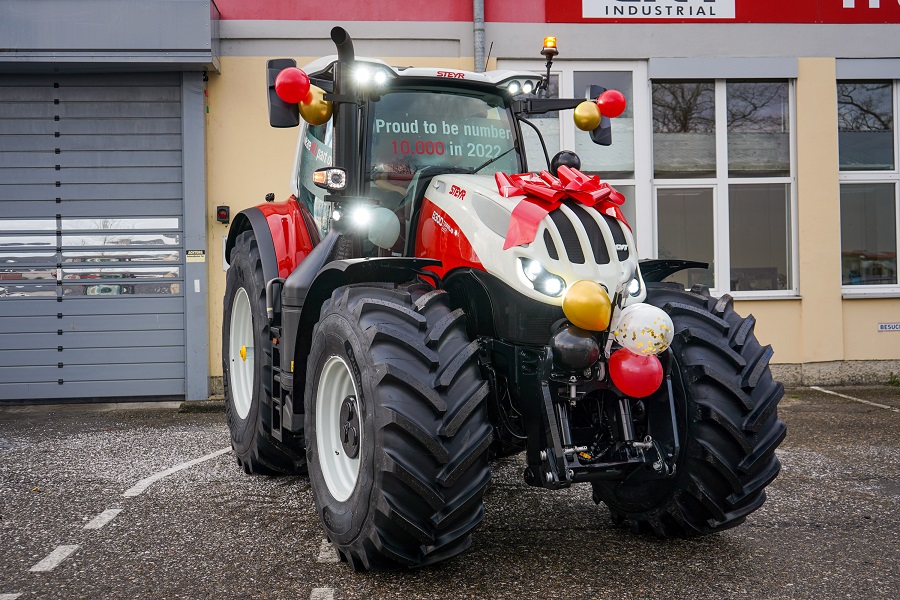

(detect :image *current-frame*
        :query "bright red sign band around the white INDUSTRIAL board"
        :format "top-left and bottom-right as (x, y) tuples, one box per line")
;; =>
(544, 0), (900, 24)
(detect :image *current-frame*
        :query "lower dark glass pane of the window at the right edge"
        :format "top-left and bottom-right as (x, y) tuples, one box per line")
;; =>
(841, 183), (897, 285)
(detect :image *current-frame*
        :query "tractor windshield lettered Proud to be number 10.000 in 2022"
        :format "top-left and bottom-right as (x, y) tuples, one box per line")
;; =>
(365, 87), (520, 210)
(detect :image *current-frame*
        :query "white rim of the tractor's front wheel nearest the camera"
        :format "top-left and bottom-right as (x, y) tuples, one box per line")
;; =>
(316, 356), (363, 502)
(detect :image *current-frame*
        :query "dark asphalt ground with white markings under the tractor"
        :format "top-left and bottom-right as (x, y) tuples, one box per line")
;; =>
(0, 387), (900, 600)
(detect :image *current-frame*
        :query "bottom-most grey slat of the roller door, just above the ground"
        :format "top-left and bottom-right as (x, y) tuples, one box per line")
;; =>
(0, 378), (184, 401)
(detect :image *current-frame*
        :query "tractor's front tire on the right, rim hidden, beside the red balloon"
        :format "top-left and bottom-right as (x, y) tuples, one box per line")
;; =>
(593, 283), (787, 537)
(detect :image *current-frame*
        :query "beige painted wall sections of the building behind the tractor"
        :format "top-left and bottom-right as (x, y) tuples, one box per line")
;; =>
(207, 57), (900, 384)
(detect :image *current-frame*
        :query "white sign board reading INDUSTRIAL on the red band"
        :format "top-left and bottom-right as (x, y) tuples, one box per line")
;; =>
(581, 0), (735, 19)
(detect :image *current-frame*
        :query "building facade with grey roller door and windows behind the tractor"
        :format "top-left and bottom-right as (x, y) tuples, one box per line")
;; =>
(0, 0), (900, 399)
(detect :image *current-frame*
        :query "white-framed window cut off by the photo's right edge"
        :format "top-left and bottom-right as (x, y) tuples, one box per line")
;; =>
(837, 80), (900, 295)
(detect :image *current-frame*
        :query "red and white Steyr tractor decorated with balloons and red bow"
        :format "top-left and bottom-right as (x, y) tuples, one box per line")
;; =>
(222, 28), (786, 569)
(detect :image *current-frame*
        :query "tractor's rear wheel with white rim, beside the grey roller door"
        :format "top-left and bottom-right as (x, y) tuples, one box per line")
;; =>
(222, 231), (306, 475)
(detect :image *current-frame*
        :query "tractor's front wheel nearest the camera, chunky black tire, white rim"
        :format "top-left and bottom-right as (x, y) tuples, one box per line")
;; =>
(305, 284), (491, 570)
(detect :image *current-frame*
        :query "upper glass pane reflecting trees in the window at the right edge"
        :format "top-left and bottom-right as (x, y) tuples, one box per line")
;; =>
(837, 81), (894, 171)
